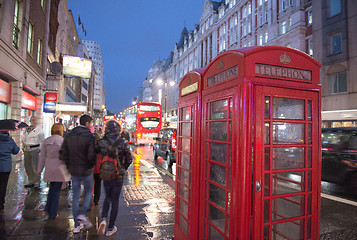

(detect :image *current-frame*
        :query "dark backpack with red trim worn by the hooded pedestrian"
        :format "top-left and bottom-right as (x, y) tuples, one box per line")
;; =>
(99, 138), (125, 181)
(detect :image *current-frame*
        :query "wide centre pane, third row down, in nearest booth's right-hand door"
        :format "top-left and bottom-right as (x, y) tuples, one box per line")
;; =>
(273, 147), (305, 170)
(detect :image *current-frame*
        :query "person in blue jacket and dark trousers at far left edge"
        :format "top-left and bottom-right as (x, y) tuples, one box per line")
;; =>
(0, 132), (20, 210)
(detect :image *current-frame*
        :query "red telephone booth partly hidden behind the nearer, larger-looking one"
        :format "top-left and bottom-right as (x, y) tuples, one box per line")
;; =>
(175, 68), (204, 239)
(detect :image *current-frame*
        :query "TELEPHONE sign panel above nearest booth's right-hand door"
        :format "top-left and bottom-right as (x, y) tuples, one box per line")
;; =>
(255, 63), (312, 81)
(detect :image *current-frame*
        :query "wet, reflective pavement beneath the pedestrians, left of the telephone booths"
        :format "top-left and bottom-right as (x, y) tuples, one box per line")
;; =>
(0, 148), (175, 240)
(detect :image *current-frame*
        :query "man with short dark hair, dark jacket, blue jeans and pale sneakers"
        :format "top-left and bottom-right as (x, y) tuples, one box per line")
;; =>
(60, 115), (97, 233)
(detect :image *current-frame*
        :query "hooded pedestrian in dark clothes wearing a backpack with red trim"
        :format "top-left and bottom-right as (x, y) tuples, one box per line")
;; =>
(97, 120), (133, 236)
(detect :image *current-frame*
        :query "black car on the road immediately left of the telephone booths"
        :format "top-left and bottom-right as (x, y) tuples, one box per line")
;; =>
(153, 128), (176, 167)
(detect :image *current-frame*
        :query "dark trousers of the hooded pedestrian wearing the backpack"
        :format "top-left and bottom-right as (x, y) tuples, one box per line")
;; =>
(102, 177), (123, 229)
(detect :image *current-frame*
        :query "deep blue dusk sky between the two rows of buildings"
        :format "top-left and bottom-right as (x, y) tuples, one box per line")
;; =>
(68, 0), (204, 113)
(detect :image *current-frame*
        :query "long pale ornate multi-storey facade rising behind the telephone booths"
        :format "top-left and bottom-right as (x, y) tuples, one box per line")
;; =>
(144, 0), (313, 125)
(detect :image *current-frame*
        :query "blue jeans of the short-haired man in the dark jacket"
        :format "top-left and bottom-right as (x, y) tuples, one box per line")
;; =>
(72, 174), (93, 227)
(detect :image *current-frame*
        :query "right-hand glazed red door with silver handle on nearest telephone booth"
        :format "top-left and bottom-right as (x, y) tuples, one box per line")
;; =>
(252, 86), (320, 240)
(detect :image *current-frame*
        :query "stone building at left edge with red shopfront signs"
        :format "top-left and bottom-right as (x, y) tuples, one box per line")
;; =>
(0, 0), (50, 144)
